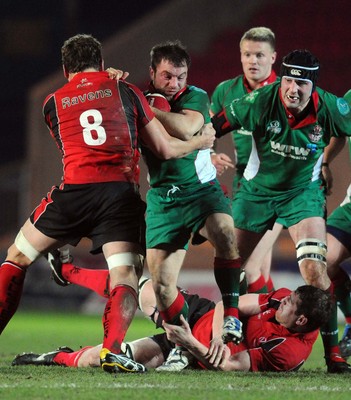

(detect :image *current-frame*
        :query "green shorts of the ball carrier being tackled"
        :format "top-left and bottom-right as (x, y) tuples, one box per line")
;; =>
(146, 180), (232, 249)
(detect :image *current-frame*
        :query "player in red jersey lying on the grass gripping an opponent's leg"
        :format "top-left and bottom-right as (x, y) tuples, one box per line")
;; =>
(12, 252), (331, 372)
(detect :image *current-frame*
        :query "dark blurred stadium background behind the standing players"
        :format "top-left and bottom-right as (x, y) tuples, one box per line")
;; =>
(0, 0), (351, 312)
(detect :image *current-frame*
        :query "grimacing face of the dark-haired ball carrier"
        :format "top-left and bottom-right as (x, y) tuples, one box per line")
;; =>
(150, 60), (188, 100)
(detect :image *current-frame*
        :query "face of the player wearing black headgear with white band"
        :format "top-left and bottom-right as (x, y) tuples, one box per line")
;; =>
(280, 77), (312, 115)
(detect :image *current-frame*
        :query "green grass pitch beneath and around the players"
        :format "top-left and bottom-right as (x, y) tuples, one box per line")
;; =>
(0, 312), (351, 400)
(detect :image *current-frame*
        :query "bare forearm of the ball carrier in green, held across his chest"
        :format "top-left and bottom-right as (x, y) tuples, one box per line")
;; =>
(152, 107), (205, 140)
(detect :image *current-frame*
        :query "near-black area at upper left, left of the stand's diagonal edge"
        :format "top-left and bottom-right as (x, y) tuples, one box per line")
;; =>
(0, 0), (165, 166)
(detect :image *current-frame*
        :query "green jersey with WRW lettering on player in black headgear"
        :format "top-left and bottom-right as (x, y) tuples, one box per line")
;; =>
(217, 82), (351, 194)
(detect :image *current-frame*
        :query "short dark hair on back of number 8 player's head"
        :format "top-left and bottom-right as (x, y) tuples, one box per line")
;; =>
(61, 34), (102, 73)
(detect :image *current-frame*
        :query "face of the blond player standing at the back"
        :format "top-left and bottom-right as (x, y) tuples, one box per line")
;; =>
(240, 40), (277, 89)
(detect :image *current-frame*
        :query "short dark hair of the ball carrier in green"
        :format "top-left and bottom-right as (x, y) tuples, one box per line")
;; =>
(150, 40), (191, 71)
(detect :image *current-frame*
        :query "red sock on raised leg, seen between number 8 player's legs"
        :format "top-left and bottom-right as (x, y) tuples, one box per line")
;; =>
(61, 263), (110, 298)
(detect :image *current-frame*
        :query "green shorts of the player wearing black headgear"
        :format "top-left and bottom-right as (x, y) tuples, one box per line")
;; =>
(232, 179), (326, 233)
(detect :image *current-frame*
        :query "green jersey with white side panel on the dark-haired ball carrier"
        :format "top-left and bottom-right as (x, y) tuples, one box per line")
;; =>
(142, 85), (216, 187)
